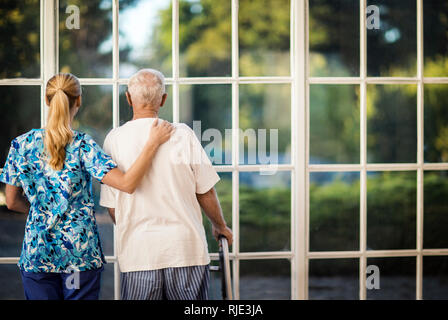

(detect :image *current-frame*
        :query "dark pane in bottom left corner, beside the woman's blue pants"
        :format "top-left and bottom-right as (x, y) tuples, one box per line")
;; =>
(0, 264), (25, 300)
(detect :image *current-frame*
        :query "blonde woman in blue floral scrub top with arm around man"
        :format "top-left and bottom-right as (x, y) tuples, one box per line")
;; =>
(0, 73), (174, 300)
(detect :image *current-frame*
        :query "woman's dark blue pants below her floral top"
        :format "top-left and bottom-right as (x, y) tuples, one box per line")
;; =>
(20, 267), (104, 300)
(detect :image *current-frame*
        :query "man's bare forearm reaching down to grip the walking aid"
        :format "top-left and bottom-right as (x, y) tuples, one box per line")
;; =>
(196, 188), (233, 246)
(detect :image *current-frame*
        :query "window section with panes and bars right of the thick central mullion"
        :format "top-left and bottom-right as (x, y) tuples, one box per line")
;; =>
(310, 0), (448, 299)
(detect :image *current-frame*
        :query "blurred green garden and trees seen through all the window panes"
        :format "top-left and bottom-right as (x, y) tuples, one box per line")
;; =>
(0, 0), (448, 299)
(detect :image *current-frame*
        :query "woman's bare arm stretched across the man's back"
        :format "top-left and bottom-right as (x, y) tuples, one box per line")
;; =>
(101, 120), (174, 194)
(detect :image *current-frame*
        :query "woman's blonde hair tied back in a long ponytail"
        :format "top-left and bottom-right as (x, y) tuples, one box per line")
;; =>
(44, 73), (81, 170)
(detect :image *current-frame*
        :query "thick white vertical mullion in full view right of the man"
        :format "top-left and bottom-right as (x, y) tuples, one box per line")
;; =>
(291, 0), (308, 300)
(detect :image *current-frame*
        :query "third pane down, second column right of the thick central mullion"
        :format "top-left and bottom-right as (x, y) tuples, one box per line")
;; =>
(367, 171), (417, 250)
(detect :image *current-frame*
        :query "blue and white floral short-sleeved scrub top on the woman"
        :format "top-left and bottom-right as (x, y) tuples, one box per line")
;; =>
(0, 129), (117, 272)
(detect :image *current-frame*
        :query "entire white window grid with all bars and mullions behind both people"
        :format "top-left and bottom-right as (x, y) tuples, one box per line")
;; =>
(0, 0), (448, 300)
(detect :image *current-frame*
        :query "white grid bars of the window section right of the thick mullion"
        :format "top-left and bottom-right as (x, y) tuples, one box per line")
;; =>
(305, 0), (448, 300)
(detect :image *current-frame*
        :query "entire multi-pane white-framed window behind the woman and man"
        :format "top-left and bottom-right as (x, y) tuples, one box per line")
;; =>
(0, 0), (448, 299)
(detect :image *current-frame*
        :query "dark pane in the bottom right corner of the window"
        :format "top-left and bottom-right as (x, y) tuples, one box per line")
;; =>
(423, 257), (448, 300)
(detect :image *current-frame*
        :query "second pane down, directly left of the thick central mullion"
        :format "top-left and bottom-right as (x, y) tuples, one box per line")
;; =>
(239, 84), (291, 164)
